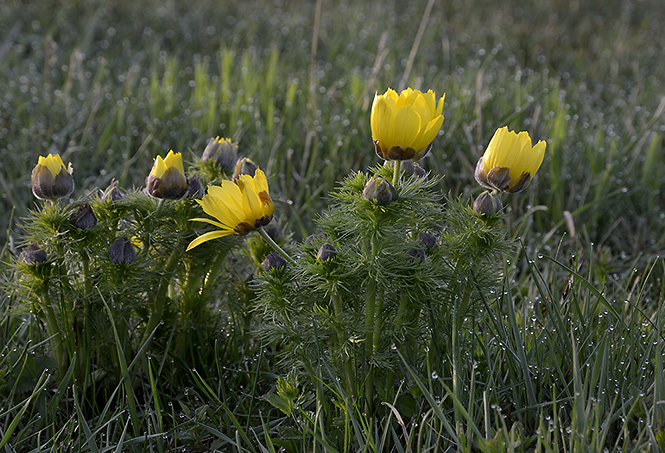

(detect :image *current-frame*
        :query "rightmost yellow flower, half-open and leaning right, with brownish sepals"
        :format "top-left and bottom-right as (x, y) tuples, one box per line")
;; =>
(475, 126), (546, 193)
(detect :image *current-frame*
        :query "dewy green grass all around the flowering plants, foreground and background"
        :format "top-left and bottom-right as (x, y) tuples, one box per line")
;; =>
(0, 0), (665, 452)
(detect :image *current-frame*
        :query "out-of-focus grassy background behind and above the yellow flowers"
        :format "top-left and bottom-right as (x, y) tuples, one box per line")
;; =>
(0, 0), (665, 264)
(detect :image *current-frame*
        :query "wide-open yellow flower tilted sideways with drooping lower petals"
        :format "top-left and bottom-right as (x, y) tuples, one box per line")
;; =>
(187, 169), (275, 250)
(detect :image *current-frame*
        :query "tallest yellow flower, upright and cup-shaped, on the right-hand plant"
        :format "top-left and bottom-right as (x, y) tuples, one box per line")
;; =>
(371, 88), (446, 160)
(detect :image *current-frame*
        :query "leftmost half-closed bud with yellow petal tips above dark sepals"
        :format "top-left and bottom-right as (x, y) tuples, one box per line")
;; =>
(32, 154), (74, 200)
